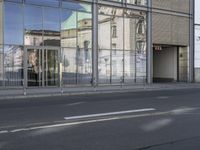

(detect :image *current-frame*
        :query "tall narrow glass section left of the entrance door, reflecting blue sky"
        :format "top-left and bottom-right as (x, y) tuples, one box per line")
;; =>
(3, 2), (24, 86)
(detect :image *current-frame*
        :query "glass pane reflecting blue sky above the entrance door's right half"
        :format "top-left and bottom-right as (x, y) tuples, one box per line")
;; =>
(43, 8), (60, 46)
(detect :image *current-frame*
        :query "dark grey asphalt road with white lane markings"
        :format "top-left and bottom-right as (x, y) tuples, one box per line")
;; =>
(0, 88), (200, 150)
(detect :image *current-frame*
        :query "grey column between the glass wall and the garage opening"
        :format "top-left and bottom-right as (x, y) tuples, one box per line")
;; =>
(147, 0), (153, 84)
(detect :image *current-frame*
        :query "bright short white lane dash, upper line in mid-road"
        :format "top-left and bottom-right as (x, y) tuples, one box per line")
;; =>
(64, 108), (156, 120)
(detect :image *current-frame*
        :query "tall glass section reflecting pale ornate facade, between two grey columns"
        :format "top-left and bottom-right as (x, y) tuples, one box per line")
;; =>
(98, 6), (146, 84)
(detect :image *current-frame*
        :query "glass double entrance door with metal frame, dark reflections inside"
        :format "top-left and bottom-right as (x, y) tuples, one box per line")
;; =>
(26, 47), (59, 87)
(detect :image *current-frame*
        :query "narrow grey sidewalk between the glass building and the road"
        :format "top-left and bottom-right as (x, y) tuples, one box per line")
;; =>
(0, 83), (200, 100)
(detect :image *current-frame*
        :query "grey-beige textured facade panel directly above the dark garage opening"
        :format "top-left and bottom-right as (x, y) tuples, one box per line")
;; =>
(152, 13), (189, 46)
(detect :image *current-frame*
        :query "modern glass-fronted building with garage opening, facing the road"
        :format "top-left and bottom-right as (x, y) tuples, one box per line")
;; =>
(0, 0), (194, 88)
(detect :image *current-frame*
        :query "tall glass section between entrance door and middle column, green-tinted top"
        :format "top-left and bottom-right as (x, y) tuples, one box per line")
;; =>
(61, 2), (92, 85)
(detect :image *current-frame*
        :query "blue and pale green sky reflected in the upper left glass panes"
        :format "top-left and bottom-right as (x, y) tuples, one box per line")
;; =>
(4, 0), (91, 45)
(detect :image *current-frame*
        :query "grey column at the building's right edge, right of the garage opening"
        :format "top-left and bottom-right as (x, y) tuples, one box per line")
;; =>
(188, 0), (195, 82)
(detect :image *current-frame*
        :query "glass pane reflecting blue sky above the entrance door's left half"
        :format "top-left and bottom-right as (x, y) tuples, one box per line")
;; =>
(24, 6), (43, 46)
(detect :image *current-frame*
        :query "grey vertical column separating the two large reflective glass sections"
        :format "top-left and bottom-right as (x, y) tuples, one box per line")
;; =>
(92, 0), (98, 87)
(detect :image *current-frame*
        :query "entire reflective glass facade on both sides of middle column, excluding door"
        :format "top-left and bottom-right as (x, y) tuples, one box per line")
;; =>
(0, 0), (146, 86)
